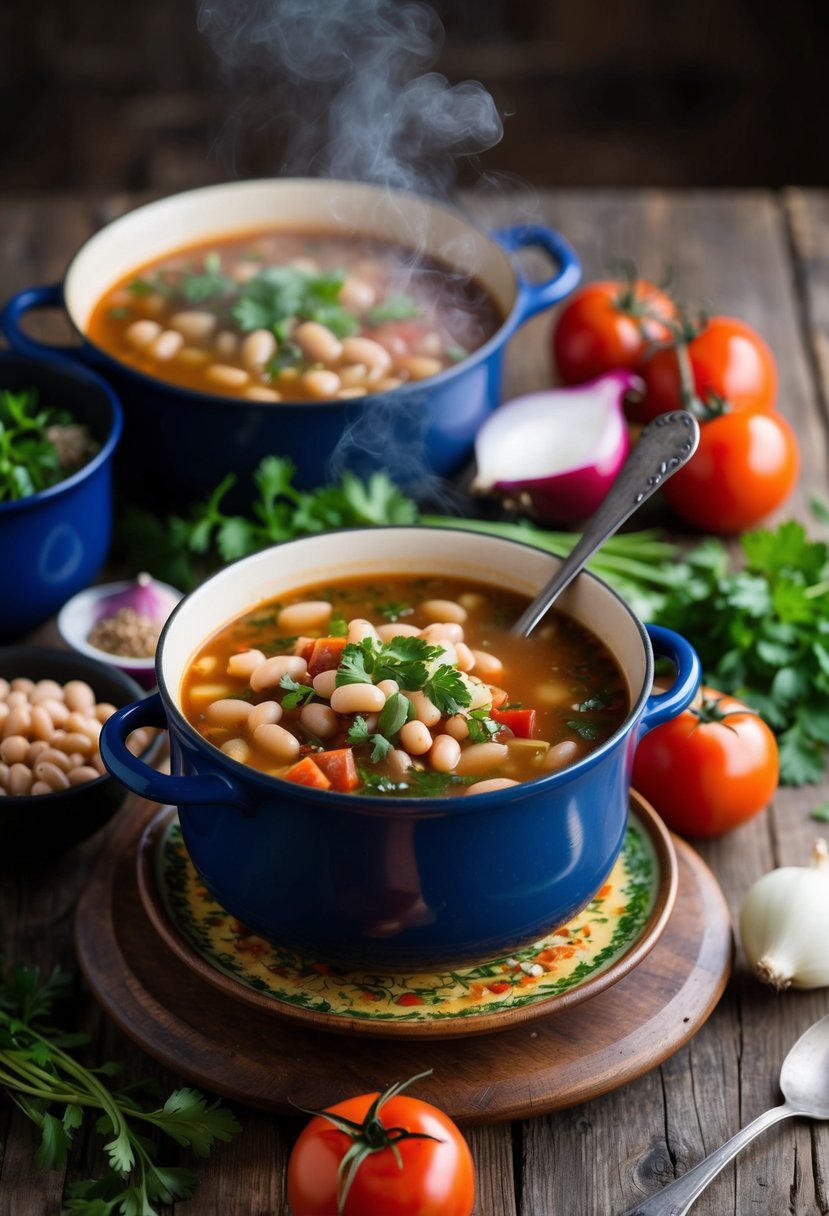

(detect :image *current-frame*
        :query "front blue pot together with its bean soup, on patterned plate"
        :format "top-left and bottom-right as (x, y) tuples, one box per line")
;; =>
(101, 528), (699, 974)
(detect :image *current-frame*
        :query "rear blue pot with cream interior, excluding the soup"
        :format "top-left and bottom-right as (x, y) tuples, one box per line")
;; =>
(0, 179), (581, 502)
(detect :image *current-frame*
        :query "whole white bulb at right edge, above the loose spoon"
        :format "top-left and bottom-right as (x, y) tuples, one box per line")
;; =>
(739, 839), (829, 991)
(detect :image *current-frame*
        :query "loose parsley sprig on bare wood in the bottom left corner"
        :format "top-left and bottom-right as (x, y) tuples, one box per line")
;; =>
(0, 967), (239, 1216)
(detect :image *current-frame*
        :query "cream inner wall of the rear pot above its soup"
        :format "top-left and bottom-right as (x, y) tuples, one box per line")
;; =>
(64, 178), (515, 332)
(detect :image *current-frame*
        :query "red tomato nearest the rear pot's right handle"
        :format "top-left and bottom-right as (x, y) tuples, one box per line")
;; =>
(553, 280), (675, 384)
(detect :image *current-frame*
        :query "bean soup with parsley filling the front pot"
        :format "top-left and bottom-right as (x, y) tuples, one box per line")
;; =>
(181, 578), (628, 796)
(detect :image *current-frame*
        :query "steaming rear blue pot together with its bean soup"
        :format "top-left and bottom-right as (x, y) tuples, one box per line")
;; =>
(0, 178), (581, 503)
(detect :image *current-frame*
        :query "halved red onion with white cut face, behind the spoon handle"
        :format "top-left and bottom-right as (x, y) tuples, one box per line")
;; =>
(472, 371), (641, 524)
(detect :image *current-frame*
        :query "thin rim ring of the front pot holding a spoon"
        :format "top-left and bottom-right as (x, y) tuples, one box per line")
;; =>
(156, 524), (654, 818)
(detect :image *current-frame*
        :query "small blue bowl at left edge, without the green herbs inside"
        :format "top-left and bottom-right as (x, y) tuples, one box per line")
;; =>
(0, 351), (123, 642)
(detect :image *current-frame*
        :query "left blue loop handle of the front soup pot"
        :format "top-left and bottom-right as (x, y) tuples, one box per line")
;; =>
(100, 693), (236, 806)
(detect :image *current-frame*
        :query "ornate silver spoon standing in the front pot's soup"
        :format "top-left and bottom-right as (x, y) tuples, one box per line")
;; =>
(511, 410), (699, 637)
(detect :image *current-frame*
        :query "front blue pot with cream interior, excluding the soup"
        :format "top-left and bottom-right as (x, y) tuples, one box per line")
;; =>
(101, 528), (700, 969)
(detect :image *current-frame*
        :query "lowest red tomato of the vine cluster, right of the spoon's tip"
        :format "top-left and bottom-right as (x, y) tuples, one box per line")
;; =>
(662, 412), (800, 533)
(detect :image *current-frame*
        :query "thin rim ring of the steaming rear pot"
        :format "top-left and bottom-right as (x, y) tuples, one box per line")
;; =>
(62, 178), (529, 413)
